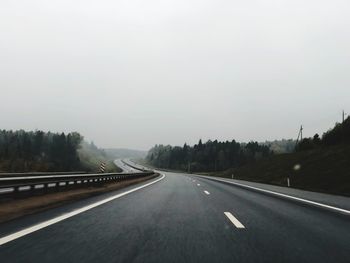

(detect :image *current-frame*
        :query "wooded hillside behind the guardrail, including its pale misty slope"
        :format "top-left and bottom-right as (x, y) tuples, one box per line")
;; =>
(0, 130), (120, 172)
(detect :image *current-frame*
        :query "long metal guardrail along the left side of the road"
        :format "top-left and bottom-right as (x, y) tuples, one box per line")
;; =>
(0, 171), (154, 197)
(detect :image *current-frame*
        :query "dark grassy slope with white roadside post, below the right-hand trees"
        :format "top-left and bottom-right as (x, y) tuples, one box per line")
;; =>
(220, 145), (350, 196)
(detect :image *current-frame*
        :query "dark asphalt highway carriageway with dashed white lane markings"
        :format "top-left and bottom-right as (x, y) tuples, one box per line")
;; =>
(0, 166), (350, 262)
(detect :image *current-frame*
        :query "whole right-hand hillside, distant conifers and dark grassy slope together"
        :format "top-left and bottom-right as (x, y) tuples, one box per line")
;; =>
(145, 117), (350, 196)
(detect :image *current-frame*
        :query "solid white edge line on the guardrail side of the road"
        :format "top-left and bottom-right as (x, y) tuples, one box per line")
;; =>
(0, 174), (165, 246)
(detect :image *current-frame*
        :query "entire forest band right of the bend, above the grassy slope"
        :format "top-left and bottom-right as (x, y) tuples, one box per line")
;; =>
(146, 117), (350, 172)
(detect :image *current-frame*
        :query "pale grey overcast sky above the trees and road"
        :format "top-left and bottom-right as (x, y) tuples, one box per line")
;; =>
(0, 0), (350, 149)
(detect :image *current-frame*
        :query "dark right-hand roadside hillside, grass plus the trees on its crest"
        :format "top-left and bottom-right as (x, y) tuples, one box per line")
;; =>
(220, 117), (350, 196)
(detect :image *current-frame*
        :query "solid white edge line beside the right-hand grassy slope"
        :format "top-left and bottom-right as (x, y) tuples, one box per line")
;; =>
(197, 175), (350, 215)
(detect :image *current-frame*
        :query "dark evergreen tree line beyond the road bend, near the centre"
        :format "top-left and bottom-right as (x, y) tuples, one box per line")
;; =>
(146, 140), (272, 172)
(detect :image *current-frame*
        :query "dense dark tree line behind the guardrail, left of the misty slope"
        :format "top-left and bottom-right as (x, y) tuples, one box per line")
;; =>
(0, 130), (83, 172)
